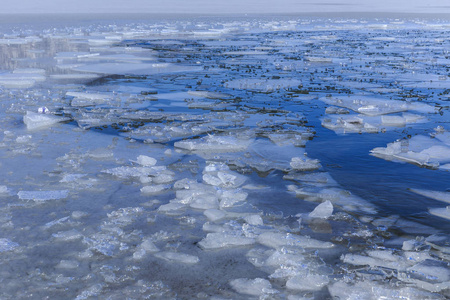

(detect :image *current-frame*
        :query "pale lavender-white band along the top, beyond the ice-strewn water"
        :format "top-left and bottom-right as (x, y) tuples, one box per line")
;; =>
(0, 0), (450, 14)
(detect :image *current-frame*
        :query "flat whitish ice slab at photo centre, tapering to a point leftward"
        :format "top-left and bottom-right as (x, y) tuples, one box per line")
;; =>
(174, 135), (252, 152)
